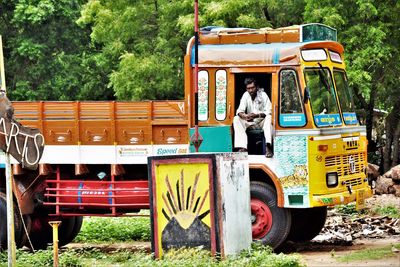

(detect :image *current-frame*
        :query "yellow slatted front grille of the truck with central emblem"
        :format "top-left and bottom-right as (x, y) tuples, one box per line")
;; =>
(325, 153), (366, 182)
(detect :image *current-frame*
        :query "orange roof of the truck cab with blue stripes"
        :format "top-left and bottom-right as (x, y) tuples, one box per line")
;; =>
(187, 23), (344, 67)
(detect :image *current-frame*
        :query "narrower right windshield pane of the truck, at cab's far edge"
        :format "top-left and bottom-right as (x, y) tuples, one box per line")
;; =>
(333, 70), (358, 124)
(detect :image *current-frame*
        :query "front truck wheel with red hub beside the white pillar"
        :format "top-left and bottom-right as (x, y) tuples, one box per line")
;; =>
(250, 181), (291, 249)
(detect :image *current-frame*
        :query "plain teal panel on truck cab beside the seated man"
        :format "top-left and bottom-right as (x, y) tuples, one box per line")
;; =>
(190, 126), (232, 152)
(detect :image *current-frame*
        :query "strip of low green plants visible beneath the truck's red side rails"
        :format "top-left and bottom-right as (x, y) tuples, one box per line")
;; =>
(75, 217), (150, 243)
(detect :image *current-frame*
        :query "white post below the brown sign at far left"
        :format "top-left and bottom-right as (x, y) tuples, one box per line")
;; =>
(5, 153), (16, 267)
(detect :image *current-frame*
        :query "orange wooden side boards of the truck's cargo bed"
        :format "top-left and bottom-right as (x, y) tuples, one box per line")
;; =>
(13, 101), (188, 145)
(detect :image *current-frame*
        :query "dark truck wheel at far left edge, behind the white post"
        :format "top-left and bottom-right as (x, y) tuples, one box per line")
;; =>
(0, 193), (22, 251)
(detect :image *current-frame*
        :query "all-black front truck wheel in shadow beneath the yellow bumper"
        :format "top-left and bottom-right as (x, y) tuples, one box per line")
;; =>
(288, 207), (327, 242)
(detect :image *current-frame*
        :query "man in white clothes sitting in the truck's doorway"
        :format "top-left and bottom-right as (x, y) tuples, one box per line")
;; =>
(233, 78), (273, 158)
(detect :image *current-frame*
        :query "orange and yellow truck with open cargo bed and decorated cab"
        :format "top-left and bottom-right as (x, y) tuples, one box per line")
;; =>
(0, 23), (373, 251)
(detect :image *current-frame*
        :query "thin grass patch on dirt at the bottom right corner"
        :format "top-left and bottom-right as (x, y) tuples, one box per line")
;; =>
(337, 244), (400, 262)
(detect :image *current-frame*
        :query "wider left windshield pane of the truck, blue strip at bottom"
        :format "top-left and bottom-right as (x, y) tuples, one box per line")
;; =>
(305, 67), (342, 127)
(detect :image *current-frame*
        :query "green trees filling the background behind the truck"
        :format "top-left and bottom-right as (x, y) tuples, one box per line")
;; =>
(0, 0), (400, 169)
